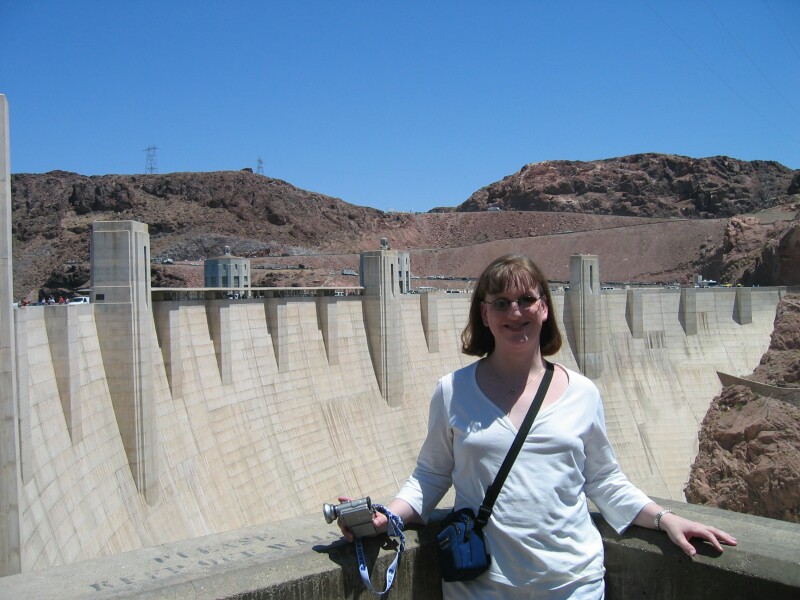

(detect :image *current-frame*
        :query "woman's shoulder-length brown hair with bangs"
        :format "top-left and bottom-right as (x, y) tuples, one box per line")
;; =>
(461, 254), (561, 356)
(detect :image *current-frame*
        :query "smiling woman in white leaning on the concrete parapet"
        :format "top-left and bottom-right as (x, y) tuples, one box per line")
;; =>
(340, 255), (736, 600)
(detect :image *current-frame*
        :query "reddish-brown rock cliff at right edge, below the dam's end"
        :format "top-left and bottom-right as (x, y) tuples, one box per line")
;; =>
(684, 295), (800, 523)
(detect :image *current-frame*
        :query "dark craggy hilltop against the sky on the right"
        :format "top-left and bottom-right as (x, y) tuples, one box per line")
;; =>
(459, 154), (800, 218)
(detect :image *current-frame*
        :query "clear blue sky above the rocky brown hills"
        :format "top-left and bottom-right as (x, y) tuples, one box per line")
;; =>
(0, 0), (800, 211)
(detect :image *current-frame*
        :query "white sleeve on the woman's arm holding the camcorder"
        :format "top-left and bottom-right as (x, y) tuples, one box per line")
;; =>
(397, 375), (454, 522)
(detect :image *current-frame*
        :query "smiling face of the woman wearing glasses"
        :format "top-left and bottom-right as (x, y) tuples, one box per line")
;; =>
(481, 284), (548, 351)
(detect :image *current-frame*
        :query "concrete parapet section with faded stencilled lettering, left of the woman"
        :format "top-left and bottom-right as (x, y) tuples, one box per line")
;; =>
(0, 511), (444, 600)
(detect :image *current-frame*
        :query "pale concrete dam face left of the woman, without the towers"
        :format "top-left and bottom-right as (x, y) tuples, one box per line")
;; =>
(7, 296), (464, 572)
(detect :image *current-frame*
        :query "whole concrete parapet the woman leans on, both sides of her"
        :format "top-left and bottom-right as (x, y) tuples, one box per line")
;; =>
(0, 500), (800, 600)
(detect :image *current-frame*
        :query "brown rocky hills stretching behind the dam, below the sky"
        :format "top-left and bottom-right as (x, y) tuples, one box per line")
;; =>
(11, 154), (800, 300)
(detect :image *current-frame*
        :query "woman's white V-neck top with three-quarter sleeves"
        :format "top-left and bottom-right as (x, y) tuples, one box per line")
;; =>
(397, 362), (650, 590)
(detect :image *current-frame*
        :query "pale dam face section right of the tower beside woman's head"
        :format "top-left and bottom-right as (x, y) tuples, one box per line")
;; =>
(595, 289), (780, 499)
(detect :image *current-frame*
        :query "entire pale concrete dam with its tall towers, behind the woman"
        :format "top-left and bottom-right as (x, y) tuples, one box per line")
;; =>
(0, 98), (800, 597)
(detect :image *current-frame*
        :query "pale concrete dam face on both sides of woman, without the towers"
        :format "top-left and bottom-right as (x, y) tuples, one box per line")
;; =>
(4, 272), (781, 572)
